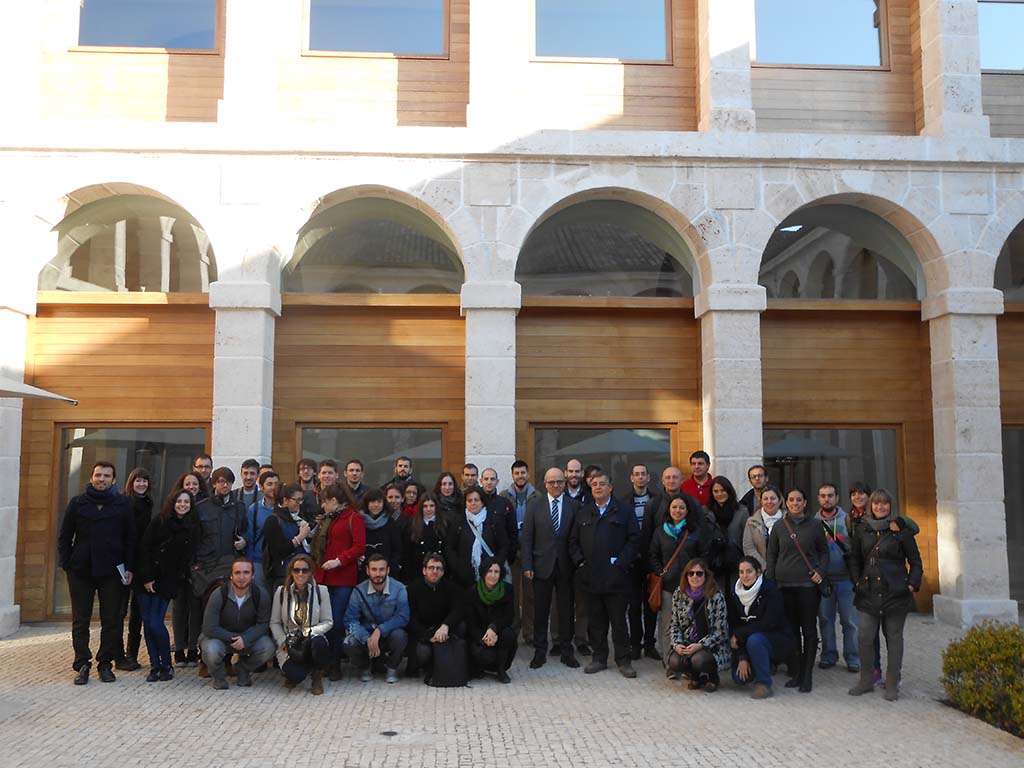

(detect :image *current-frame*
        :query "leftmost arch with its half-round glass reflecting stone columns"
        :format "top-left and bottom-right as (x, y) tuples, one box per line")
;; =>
(35, 181), (217, 293)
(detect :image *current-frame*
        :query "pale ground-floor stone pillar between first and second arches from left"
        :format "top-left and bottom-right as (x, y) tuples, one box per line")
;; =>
(210, 281), (281, 472)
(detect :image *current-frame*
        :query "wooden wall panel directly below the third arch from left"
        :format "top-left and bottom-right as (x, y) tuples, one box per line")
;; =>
(516, 308), (702, 475)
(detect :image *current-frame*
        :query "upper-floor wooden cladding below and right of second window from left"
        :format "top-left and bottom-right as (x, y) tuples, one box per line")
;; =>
(278, 0), (469, 126)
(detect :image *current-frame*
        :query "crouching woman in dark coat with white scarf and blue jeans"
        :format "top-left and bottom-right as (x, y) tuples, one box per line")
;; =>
(729, 556), (796, 698)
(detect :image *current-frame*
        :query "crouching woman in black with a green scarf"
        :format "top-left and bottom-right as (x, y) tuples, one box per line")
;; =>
(466, 557), (517, 683)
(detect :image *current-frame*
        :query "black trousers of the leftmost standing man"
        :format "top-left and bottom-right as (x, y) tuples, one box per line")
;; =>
(67, 570), (124, 672)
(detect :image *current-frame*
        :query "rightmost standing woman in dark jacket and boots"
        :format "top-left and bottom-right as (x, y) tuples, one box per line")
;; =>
(850, 488), (924, 701)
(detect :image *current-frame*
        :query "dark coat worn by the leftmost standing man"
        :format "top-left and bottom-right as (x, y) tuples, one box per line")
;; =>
(57, 485), (138, 579)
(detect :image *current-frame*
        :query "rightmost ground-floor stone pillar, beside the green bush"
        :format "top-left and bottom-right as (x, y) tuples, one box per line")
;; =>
(923, 289), (1017, 626)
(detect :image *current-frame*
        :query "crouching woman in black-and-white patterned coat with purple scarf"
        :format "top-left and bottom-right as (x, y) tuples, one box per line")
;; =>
(669, 559), (731, 693)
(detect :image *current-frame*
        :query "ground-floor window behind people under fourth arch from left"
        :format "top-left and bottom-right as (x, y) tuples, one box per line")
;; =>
(764, 429), (899, 509)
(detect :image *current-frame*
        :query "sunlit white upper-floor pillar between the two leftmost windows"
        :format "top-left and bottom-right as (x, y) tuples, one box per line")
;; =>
(217, 0), (280, 123)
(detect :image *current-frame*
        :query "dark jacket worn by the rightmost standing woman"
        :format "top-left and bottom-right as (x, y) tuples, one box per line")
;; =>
(847, 525), (925, 614)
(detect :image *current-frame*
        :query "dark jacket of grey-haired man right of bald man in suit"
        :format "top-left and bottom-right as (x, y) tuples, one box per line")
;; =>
(569, 499), (643, 594)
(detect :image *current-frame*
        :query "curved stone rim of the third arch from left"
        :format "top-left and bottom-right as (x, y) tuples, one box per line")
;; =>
(516, 186), (708, 296)
